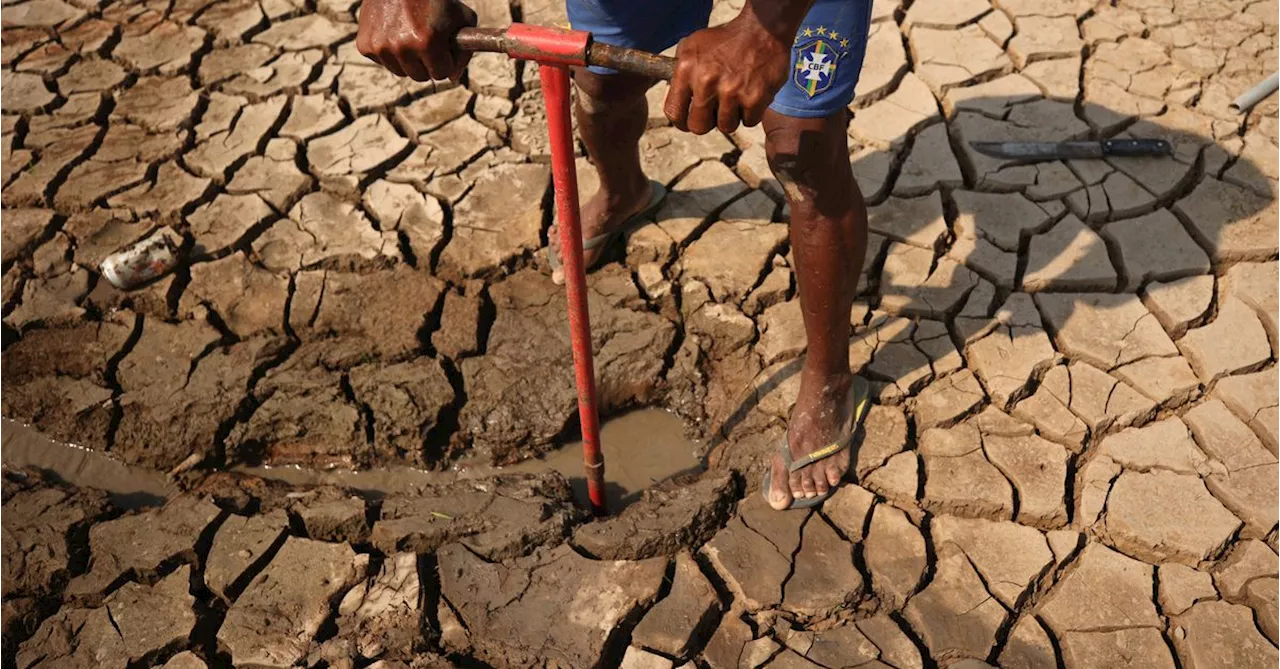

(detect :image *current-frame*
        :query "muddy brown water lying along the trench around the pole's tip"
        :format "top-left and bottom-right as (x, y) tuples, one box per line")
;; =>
(0, 409), (703, 512)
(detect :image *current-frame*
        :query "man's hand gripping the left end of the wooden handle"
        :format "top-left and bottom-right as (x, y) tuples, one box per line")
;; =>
(356, 0), (476, 82)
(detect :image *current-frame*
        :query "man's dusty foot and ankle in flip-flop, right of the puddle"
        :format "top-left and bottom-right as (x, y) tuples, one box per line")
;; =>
(769, 367), (854, 510)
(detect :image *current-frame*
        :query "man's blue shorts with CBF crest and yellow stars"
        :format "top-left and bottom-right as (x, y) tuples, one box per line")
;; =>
(566, 0), (872, 119)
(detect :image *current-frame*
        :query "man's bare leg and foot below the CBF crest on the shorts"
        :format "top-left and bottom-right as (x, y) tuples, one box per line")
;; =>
(764, 110), (867, 509)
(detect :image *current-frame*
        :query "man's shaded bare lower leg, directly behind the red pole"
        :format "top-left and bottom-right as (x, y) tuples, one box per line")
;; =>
(550, 69), (654, 283)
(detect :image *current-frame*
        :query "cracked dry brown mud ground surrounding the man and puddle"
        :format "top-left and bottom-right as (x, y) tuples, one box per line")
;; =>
(0, 0), (1280, 669)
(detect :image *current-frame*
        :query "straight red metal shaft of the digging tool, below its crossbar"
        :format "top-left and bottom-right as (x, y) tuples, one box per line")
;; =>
(538, 63), (608, 516)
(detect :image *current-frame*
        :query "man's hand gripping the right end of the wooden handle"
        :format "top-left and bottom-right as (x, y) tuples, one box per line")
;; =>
(663, 0), (812, 134)
